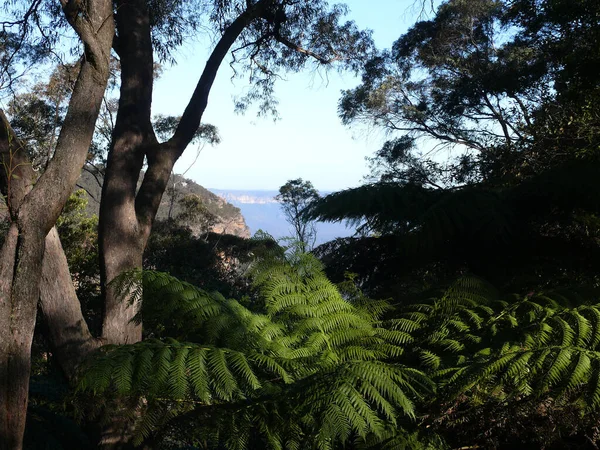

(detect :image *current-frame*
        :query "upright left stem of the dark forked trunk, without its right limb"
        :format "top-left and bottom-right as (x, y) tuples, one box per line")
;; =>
(98, 0), (157, 344)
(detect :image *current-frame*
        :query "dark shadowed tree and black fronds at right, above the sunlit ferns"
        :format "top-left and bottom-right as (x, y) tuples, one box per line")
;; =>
(308, 0), (600, 304)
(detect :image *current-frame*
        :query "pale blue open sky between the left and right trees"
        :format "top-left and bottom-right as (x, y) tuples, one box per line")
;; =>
(153, 0), (428, 191)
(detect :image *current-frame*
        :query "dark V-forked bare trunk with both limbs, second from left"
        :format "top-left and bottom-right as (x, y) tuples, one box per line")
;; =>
(99, 0), (271, 344)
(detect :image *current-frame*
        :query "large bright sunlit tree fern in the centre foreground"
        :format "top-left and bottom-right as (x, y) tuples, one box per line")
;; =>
(79, 253), (433, 448)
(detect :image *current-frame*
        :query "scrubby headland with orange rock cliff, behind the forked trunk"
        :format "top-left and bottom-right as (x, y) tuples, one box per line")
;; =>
(77, 171), (250, 238)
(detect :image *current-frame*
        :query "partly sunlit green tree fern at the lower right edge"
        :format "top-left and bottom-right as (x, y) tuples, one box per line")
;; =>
(404, 280), (600, 418)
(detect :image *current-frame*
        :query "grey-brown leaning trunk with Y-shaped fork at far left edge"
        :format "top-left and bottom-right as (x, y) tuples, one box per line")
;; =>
(0, 0), (114, 450)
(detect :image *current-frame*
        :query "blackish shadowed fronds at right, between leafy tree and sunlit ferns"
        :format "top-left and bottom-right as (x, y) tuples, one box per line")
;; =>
(308, 161), (600, 298)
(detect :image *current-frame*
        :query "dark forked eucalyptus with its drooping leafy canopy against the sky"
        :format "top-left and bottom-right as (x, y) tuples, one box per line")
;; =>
(55, 0), (371, 356)
